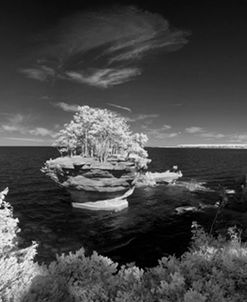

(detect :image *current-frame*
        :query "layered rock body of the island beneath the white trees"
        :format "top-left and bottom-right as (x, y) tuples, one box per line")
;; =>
(42, 156), (137, 208)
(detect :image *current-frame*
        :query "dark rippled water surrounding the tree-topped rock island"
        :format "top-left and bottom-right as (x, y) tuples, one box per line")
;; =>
(0, 147), (247, 266)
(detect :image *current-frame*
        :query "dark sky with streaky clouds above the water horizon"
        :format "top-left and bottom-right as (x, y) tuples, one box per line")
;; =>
(0, 0), (247, 147)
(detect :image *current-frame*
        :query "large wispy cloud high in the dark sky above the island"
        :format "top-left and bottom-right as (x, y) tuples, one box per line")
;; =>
(20, 6), (188, 88)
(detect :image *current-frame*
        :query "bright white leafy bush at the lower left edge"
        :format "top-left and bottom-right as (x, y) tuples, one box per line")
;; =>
(0, 189), (40, 301)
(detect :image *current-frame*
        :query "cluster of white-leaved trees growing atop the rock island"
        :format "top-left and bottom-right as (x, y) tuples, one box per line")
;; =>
(54, 106), (148, 168)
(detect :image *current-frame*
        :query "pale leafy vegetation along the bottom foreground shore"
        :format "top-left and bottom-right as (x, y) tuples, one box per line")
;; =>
(0, 192), (247, 302)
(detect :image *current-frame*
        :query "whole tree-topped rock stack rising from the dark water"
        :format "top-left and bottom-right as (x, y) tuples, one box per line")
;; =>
(42, 106), (150, 211)
